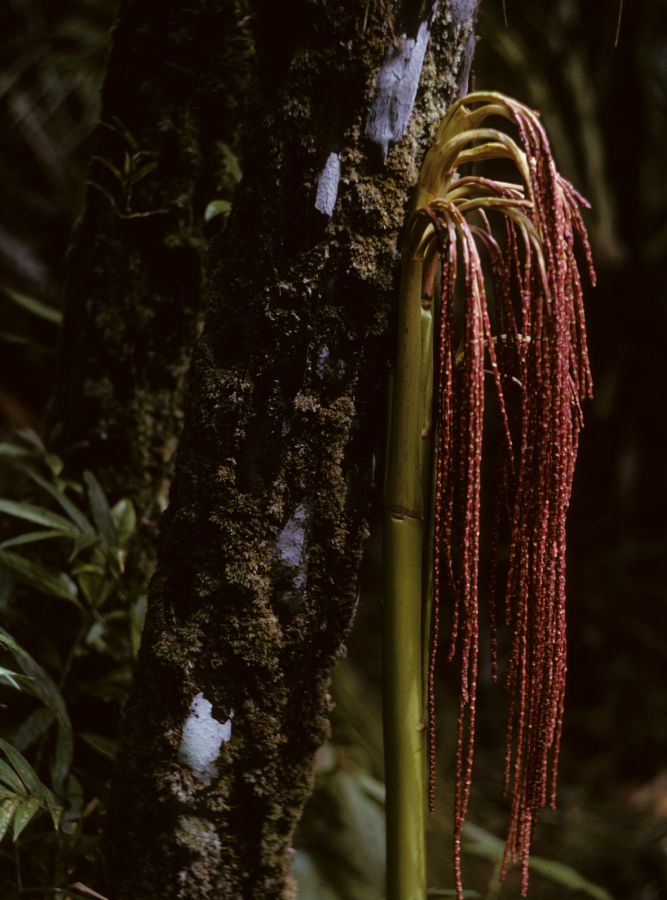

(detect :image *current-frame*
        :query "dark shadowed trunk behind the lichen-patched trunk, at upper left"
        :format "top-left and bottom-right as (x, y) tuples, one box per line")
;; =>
(51, 0), (247, 536)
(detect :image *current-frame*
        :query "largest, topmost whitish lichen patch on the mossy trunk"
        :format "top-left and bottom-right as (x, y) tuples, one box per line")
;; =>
(366, 3), (437, 156)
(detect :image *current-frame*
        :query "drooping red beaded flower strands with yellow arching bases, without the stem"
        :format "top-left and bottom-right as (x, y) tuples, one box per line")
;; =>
(407, 93), (595, 897)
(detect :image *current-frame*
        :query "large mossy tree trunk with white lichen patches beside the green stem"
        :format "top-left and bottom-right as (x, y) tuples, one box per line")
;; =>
(113, 0), (476, 900)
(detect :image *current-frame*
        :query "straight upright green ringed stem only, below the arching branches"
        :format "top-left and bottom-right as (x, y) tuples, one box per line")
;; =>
(383, 206), (433, 900)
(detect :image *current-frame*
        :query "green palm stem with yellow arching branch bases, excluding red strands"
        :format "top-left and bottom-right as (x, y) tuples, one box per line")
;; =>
(383, 93), (526, 900)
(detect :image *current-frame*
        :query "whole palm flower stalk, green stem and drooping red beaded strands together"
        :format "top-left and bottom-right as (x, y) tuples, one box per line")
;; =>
(384, 92), (594, 900)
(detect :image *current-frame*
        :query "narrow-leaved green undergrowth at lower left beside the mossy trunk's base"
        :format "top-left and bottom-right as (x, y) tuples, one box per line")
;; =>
(0, 432), (140, 900)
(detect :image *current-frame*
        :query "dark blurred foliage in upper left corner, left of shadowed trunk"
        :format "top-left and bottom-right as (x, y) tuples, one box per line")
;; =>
(0, 0), (117, 386)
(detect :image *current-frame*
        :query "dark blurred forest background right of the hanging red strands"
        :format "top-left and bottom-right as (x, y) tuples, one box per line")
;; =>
(468, 0), (667, 900)
